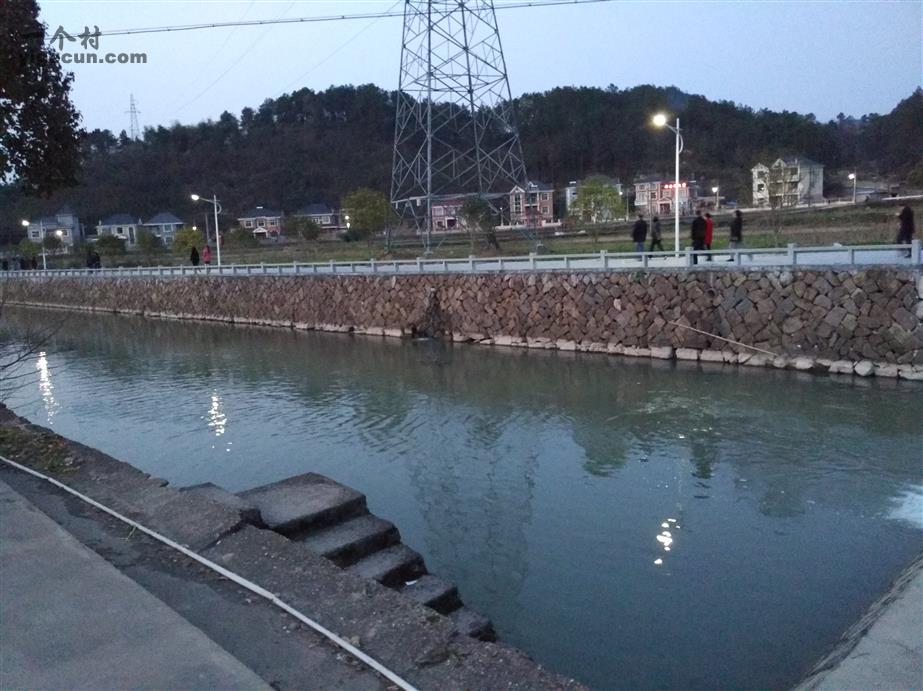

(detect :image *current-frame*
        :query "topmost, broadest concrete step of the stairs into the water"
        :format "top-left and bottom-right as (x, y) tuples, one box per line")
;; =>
(239, 473), (368, 536)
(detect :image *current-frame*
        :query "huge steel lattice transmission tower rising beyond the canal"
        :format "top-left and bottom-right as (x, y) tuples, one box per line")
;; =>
(391, 0), (527, 250)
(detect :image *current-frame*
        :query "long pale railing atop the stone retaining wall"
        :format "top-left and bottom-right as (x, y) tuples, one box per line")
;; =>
(0, 240), (921, 278)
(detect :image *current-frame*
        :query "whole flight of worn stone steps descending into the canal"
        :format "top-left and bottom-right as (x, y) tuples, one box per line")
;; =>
(186, 473), (496, 641)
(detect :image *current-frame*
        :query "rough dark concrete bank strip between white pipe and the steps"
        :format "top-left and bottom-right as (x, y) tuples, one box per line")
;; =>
(0, 407), (580, 689)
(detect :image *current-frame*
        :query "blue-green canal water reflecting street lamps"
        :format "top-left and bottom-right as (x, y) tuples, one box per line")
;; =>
(0, 308), (923, 689)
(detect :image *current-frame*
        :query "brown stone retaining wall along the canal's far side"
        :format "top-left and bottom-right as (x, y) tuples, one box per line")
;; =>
(0, 268), (923, 379)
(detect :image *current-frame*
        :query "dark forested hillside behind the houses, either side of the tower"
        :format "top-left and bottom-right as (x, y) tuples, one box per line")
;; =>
(0, 85), (923, 234)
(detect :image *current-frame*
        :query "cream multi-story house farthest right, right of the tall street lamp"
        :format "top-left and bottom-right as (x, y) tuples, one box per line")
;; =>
(750, 156), (824, 209)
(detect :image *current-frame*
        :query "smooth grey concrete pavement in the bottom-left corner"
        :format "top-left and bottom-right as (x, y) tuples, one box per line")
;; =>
(0, 481), (269, 689)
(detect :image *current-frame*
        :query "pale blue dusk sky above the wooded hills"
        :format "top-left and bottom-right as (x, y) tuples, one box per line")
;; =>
(40, 0), (923, 133)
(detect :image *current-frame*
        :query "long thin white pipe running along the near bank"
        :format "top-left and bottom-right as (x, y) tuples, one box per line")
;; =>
(0, 456), (417, 691)
